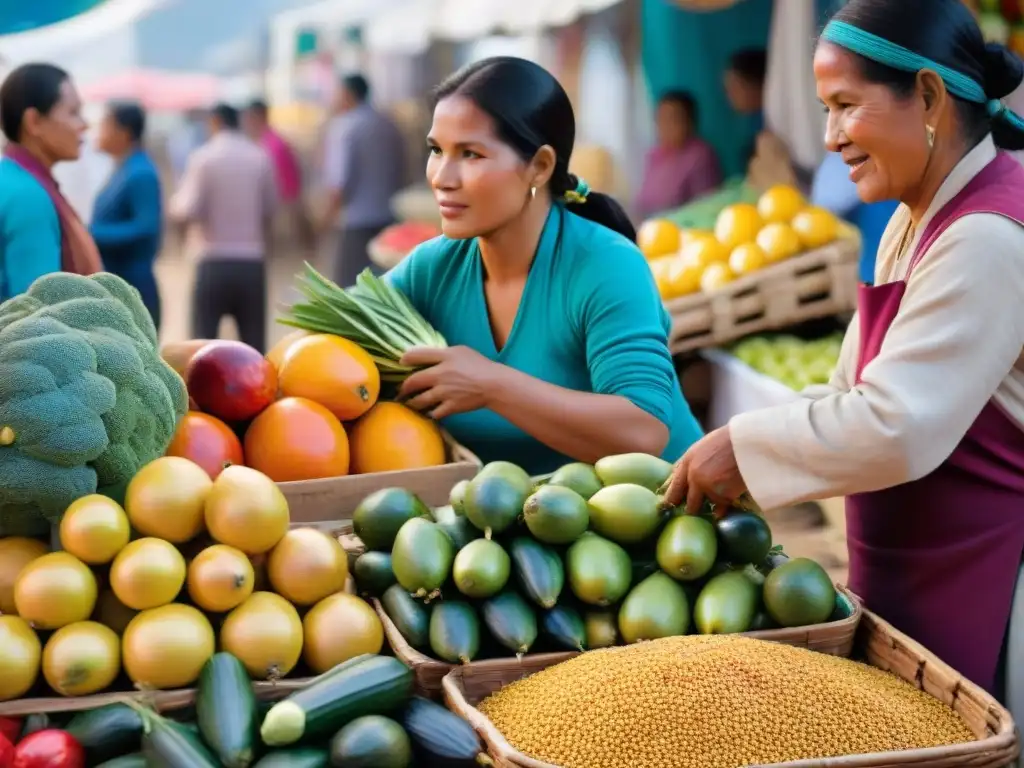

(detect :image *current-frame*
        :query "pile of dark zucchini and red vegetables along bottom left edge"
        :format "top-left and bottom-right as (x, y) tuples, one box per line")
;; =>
(0, 652), (490, 768)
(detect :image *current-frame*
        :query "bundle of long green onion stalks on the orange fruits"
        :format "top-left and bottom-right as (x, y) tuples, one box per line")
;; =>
(278, 262), (447, 384)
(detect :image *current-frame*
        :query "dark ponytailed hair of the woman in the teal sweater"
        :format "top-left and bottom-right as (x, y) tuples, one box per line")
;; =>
(434, 56), (637, 242)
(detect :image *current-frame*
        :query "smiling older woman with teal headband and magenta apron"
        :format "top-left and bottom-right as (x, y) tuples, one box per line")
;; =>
(669, 0), (1024, 710)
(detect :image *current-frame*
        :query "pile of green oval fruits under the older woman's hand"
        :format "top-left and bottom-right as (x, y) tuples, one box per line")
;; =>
(353, 454), (837, 664)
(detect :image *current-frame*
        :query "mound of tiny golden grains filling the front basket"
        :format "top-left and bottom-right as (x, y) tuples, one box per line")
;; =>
(479, 637), (975, 768)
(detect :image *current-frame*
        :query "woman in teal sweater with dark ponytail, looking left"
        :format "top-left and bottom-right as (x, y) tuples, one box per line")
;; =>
(389, 57), (701, 474)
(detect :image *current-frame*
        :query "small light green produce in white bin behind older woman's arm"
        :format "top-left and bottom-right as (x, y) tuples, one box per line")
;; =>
(730, 333), (843, 392)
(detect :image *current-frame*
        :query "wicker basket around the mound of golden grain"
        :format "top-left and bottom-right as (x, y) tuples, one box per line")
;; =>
(443, 611), (1020, 768)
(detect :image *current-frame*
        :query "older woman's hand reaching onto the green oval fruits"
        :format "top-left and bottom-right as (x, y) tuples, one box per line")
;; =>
(665, 426), (746, 514)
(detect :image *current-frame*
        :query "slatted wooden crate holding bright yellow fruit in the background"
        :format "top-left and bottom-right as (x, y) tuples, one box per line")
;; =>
(665, 236), (861, 354)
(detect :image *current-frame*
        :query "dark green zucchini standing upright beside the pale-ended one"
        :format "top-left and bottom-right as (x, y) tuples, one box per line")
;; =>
(196, 652), (259, 768)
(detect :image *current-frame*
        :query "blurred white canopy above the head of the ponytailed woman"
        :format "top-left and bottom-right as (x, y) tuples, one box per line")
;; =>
(364, 0), (621, 53)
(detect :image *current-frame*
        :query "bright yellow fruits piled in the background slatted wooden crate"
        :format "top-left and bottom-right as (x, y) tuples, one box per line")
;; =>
(637, 185), (842, 300)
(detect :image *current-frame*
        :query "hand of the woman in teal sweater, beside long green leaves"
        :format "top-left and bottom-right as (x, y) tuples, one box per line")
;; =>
(398, 346), (504, 420)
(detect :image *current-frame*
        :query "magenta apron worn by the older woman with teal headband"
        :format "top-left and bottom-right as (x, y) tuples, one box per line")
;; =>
(846, 154), (1024, 692)
